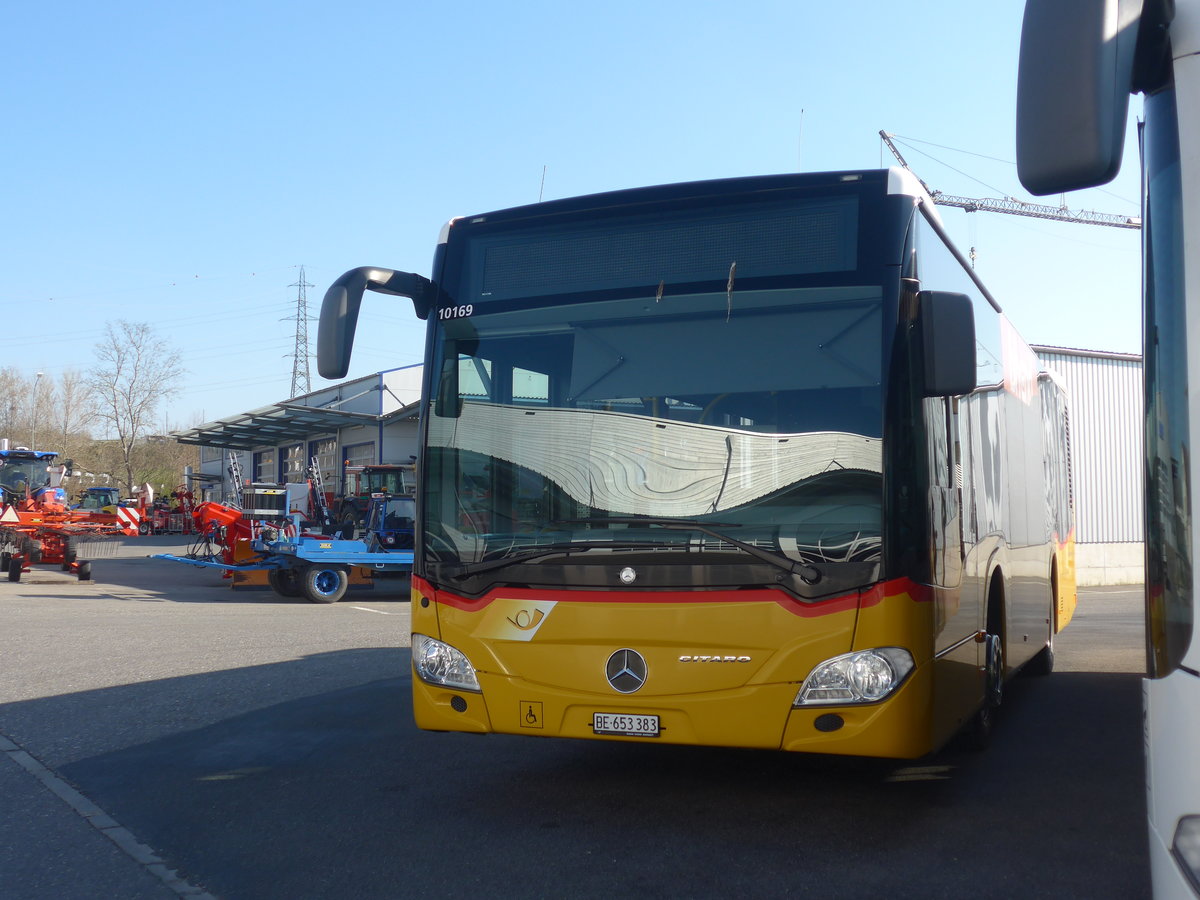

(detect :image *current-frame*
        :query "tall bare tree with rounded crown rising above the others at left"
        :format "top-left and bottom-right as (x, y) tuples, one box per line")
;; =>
(84, 319), (184, 493)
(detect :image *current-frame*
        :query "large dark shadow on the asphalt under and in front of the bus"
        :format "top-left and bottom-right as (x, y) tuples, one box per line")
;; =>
(0, 649), (1147, 898)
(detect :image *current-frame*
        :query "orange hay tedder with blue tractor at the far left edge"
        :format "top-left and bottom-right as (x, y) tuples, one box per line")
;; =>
(0, 448), (140, 581)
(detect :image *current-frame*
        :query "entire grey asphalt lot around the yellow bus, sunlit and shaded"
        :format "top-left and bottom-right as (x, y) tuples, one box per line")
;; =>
(0, 538), (1147, 900)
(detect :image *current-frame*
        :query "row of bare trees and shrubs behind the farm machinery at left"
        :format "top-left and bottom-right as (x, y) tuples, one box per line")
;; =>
(0, 320), (199, 496)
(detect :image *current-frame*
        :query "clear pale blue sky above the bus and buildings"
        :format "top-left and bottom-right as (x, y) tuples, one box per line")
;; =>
(0, 0), (1141, 428)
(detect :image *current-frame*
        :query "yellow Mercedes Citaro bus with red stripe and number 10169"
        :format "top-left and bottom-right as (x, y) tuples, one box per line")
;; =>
(318, 169), (1075, 757)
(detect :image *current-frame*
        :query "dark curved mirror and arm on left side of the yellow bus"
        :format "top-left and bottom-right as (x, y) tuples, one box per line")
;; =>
(317, 265), (437, 378)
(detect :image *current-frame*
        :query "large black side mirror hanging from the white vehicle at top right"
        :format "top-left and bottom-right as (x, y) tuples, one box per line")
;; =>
(1016, 0), (1142, 194)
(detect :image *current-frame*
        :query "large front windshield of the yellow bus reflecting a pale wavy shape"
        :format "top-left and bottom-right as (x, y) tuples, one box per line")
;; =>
(424, 286), (882, 592)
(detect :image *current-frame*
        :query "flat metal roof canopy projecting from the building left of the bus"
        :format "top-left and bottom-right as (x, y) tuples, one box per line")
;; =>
(172, 403), (419, 450)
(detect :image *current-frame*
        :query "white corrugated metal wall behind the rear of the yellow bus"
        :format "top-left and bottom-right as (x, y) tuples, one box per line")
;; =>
(1033, 347), (1142, 544)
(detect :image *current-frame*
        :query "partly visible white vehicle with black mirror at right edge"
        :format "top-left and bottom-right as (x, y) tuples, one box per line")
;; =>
(1016, 0), (1200, 898)
